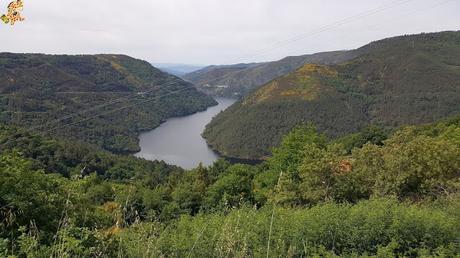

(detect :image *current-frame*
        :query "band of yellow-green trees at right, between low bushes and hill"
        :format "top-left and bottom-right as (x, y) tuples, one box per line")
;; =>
(268, 116), (460, 205)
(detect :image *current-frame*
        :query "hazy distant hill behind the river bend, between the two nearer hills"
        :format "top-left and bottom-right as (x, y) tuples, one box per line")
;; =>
(183, 51), (356, 97)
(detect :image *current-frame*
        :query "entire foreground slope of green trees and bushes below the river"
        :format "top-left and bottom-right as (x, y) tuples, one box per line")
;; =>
(0, 117), (460, 257)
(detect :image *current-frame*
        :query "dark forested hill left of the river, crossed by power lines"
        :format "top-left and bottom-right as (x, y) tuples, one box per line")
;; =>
(0, 53), (216, 153)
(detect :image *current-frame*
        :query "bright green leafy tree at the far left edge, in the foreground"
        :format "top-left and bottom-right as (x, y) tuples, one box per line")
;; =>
(0, 154), (67, 240)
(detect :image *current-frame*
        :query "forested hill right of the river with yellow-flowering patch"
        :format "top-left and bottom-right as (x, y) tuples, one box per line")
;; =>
(204, 31), (460, 159)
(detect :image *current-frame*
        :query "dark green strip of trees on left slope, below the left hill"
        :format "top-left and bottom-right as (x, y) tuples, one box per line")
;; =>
(0, 126), (182, 181)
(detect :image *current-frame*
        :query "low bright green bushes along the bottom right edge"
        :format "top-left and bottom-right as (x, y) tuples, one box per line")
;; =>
(120, 199), (460, 257)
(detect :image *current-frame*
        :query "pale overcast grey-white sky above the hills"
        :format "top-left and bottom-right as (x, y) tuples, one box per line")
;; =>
(0, 0), (460, 64)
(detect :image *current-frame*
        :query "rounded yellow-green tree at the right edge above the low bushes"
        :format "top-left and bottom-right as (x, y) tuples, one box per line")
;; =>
(353, 128), (460, 198)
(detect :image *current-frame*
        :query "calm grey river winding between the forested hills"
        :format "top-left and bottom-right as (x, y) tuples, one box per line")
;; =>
(135, 98), (236, 169)
